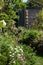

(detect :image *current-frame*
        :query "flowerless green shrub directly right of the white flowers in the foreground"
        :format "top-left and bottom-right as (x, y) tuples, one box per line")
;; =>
(19, 44), (36, 65)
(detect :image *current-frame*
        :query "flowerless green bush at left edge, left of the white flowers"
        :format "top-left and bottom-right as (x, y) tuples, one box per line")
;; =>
(0, 35), (15, 65)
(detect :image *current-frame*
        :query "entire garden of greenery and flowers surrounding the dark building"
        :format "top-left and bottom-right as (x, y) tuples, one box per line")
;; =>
(0, 0), (43, 65)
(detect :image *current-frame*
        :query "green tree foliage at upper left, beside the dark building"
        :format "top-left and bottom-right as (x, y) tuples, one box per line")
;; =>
(0, 0), (26, 31)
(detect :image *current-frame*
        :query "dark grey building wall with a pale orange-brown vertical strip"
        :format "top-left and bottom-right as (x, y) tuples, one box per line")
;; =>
(19, 7), (41, 28)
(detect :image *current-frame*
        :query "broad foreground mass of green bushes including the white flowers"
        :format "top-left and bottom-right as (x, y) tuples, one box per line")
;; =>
(0, 35), (35, 65)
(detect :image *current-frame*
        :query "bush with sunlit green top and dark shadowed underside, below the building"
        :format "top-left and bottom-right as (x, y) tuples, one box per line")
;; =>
(19, 30), (43, 53)
